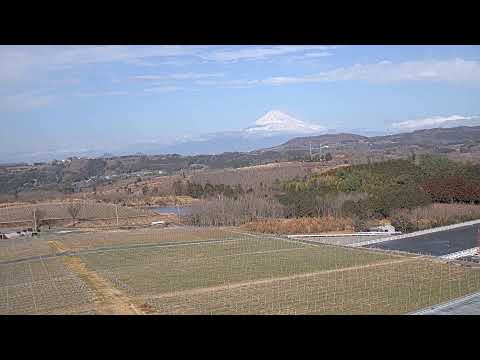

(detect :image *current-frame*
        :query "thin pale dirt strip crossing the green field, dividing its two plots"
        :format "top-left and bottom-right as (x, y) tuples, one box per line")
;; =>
(139, 257), (418, 300)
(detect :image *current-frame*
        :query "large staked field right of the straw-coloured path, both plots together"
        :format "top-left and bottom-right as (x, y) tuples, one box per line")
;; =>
(74, 238), (480, 314)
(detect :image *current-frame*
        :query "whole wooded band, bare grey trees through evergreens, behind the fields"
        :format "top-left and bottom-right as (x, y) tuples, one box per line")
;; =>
(181, 155), (480, 231)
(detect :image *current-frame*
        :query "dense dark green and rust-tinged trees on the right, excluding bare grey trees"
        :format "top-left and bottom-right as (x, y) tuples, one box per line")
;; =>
(278, 155), (480, 225)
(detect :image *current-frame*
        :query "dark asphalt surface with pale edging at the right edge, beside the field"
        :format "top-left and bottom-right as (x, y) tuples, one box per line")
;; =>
(365, 224), (480, 256)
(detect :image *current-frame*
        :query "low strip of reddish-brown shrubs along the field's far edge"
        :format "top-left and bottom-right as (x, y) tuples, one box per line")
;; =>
(243, 216), (354, 234)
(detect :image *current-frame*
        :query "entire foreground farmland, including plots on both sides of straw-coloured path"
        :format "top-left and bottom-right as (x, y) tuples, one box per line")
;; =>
(0, 227), (480, 314)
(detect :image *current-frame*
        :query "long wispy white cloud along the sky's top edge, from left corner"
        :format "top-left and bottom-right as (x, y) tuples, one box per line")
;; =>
(0, 45), (335, 80)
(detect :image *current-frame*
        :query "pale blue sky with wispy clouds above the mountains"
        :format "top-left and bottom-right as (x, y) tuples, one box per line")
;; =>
(0, 45), (480, 161)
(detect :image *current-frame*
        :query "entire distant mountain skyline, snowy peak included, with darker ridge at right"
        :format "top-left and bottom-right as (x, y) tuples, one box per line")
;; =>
(0, 110), (480, 162)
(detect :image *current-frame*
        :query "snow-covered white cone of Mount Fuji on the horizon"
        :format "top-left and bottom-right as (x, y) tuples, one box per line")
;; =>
(243, 110), (325, 135)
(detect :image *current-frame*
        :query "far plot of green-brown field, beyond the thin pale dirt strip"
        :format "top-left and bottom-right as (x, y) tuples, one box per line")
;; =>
(80, 238), (389, 296)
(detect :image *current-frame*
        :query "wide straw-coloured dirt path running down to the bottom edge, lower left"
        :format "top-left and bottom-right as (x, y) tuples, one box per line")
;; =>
(64, 256), (144, 315)
